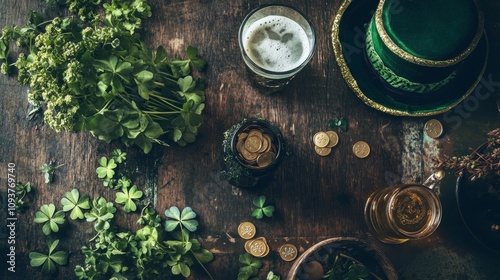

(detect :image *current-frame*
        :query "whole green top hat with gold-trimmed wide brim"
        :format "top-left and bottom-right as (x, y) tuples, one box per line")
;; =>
(332, 0), (489, 117)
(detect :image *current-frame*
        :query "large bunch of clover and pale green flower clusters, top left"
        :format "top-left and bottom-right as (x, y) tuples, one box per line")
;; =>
(0, 0), (205, 153)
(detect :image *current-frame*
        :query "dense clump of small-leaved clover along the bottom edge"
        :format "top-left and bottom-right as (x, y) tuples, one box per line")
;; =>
(75, 205), (213, 279)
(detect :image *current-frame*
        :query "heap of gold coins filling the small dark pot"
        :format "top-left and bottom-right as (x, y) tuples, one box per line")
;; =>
(236, 125), (277, 168)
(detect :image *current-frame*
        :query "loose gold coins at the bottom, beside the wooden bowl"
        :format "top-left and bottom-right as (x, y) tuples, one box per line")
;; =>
(238, 222), (298, 262)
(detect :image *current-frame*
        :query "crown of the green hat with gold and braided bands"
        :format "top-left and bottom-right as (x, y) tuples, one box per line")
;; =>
(366, 0), (484, 94)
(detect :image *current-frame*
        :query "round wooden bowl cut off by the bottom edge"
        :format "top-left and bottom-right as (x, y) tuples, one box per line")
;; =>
(286, 237), (398, 280)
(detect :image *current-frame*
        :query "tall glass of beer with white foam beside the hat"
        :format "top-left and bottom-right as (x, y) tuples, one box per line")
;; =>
(238, 4), (316, 93)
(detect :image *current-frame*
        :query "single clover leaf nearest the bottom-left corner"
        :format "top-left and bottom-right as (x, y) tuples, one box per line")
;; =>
(29, 240), (68, 274)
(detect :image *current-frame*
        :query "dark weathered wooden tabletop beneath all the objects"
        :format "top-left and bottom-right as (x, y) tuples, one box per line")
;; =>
(0, 0), (500, 279)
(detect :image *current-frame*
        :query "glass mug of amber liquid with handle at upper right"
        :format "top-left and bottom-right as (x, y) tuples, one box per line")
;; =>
(365, 171), (444, 244)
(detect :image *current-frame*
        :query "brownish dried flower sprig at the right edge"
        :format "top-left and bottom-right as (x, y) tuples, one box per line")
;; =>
(437, 128), (500, 182)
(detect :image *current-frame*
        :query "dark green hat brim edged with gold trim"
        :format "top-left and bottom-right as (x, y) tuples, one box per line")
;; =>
(332, 0), (488, 117)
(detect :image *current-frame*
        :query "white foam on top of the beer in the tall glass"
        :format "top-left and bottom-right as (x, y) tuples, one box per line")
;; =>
(243, 15), (310, 72)
